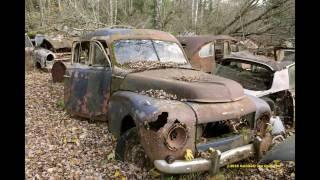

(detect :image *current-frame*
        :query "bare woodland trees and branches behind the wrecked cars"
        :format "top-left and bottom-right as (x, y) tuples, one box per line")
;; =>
(25, 0), (295, 45)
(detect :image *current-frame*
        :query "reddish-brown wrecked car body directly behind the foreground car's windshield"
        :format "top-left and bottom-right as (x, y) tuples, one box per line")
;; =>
(177, 35), (239, 73)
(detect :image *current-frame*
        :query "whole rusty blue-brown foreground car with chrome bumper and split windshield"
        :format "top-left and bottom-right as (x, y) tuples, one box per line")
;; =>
(64, 28), (271, 174)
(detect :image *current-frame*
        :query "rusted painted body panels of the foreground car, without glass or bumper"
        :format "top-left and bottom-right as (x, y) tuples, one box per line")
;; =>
(64, 29), (270, 172)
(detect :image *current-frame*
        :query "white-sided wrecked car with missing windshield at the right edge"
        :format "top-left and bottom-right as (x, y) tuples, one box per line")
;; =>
(215, 51), (295, 124)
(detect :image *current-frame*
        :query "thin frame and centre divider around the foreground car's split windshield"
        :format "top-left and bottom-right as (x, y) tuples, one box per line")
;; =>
(110, 38), (191, 68)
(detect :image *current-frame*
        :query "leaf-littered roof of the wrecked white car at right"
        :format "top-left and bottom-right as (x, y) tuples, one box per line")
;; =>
(222, 51), (292, 71)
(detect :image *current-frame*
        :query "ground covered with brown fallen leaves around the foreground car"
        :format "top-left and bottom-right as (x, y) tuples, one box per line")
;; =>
(25, 70), (295, 180)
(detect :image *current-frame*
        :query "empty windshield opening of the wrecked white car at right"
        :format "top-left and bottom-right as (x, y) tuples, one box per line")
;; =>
(215, 61), (273, 91)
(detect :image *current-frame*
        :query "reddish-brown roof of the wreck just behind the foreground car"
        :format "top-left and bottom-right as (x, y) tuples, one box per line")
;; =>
(177, 35), (237, 57)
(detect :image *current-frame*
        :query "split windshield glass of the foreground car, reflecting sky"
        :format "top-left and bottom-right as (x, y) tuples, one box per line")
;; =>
(113, 40), (187, 67)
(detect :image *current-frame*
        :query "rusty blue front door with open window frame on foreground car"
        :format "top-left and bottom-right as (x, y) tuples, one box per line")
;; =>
(65, 40), (112, 119)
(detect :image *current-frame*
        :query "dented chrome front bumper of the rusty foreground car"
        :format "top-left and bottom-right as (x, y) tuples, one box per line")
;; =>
(154, 144), (255, 174)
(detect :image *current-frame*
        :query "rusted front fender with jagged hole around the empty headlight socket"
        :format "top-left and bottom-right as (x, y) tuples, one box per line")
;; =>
(108, 91), (196, 160)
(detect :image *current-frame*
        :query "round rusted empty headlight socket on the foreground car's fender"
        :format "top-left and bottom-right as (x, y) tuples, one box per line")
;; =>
(164, 123), (189, 151)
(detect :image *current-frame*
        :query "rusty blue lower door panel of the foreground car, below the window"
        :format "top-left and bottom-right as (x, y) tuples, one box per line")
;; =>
(64, 68), (111, 120)
